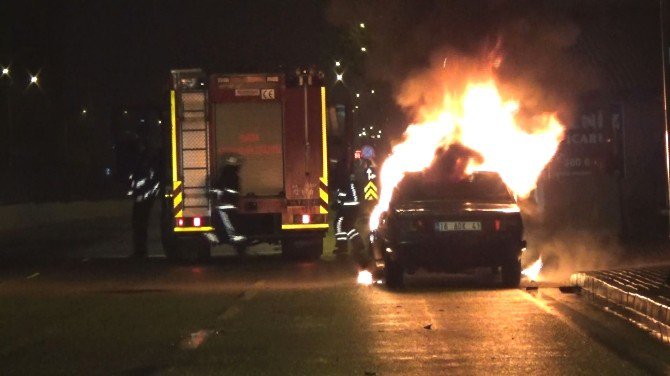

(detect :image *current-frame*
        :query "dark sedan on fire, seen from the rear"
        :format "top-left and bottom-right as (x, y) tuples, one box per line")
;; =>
(371, 171), (526, 288)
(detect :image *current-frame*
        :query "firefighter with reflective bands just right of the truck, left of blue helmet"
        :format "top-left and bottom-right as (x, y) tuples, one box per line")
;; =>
(334, 174), (364, 255)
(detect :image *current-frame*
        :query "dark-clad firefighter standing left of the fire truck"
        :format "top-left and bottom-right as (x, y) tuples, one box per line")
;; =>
(128, 136), (162, 258)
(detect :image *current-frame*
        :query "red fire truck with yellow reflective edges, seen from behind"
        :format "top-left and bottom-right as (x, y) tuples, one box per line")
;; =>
(161, 69), (329, 259)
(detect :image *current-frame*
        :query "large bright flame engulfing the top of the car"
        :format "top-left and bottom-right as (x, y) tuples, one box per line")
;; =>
(370, 74), (564, 230)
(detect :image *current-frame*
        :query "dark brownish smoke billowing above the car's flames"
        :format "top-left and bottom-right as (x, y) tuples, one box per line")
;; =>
(329, 0), (596, 120)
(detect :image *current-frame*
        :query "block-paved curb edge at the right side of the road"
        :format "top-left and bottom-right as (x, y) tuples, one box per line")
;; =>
(570, 272), (670, 344)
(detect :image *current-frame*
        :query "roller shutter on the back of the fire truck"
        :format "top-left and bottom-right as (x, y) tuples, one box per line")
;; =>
(214, 101), (284, 196)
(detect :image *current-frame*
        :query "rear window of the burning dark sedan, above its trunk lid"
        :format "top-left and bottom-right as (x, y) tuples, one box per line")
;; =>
(393, 172), (514, 203)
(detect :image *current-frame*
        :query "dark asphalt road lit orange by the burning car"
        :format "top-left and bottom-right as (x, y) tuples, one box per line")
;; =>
(0, 216), (670, 375)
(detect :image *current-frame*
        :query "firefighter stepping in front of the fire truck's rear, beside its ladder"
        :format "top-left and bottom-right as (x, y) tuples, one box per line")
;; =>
(212, 154), (247, 245)
